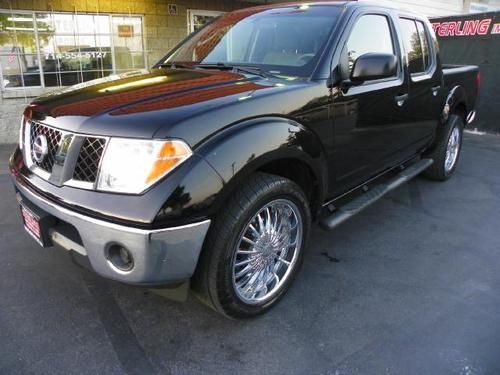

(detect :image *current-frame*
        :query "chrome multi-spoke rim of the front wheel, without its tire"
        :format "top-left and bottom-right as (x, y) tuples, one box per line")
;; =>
(232, 199), (304, 304)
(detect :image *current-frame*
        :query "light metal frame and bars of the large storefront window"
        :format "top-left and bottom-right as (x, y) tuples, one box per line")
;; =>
(0, 8), (148, 93)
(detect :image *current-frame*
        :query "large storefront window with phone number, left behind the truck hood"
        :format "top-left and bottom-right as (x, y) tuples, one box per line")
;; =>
(0, 11), (146, 89)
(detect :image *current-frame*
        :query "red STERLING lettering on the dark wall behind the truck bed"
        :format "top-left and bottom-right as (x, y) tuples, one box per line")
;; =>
(431, 13), (500, 38)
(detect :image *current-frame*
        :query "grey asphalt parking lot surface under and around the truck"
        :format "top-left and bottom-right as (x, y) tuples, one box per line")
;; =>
(0, 134), (500, 374)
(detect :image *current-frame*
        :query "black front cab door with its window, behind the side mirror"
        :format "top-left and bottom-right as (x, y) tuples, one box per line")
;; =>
(330, 12), (408, 195)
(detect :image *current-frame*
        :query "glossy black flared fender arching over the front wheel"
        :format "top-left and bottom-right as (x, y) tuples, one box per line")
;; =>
(196, 117), (328, 216)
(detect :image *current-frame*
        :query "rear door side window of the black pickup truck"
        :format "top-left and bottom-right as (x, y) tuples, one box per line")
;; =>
(399, 18), (430, 74)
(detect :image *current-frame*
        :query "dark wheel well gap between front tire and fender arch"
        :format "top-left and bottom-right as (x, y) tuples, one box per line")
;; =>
(257, 159), (321, 218)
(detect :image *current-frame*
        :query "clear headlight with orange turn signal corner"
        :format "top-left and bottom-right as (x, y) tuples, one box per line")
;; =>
(97, 138), (192, 194)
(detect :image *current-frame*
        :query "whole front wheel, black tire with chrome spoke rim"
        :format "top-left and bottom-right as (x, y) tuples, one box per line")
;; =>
(193, 172), (311, 318)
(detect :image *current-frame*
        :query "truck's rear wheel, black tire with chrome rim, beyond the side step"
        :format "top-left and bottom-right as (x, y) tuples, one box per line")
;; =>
(423, 114), (464, 181)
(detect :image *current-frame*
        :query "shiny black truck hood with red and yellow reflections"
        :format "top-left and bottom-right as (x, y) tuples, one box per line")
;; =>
(30, 69), (312, 146)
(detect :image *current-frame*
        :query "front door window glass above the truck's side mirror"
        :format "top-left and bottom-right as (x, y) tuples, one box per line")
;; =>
(343, 14), (395, 78)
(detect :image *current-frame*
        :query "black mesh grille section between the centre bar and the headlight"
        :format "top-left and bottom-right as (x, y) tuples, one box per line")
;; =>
(73, 137), (106, 183)
